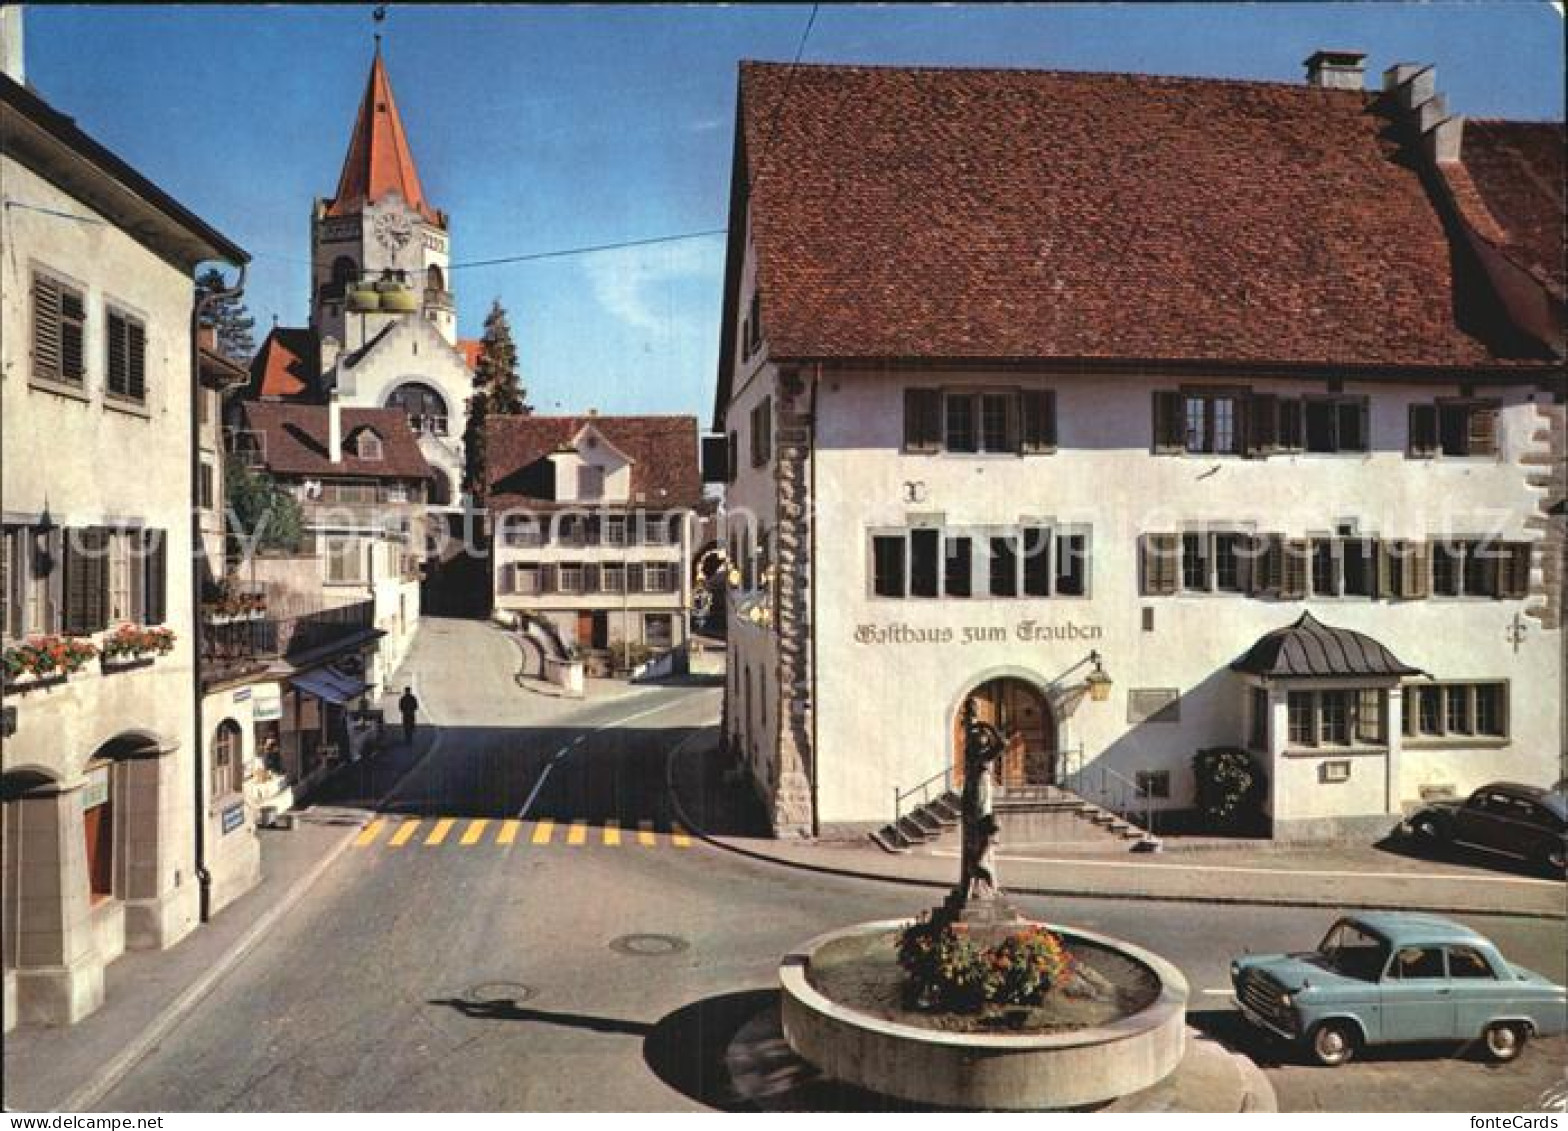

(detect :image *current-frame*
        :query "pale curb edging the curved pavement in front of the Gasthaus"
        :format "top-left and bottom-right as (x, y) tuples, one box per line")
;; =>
(665, 731), (1568, 921)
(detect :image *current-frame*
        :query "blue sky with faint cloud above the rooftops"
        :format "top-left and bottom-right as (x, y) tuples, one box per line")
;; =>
(18, 3), (1563, 419)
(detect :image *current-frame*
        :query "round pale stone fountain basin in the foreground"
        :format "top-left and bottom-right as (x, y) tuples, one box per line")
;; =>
(779, 919), (1187, 1111)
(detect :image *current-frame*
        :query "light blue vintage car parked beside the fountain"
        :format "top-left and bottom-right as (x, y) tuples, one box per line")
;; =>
(1231, 911), (1568, 1065)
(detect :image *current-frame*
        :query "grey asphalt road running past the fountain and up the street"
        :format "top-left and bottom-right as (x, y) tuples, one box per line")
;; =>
(99, 621), (1568, 1111)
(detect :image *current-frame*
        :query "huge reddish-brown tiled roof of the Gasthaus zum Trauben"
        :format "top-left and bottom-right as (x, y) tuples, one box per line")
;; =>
(721, 63), (1562, 373)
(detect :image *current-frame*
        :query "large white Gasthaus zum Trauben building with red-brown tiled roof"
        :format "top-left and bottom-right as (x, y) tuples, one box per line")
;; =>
(715, 52), (1565, 838)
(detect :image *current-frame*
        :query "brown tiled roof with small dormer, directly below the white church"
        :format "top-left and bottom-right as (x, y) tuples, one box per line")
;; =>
(243, 402), (431, 478)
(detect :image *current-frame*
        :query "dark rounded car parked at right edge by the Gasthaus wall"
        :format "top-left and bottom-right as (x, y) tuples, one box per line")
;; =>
(1400, 781), (1568, 875)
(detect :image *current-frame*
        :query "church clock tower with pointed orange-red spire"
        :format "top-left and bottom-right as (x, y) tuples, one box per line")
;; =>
(310, 38), (458, 351)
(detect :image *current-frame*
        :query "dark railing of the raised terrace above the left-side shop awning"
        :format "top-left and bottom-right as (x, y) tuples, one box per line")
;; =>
(201, 598), (375, 684)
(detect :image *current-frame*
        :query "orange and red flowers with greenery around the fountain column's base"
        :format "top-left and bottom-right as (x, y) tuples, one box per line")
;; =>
(898, 911), (1073, 1013)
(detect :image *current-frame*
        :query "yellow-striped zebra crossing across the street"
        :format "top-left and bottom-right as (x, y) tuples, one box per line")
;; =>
(354, 817), (691, 850)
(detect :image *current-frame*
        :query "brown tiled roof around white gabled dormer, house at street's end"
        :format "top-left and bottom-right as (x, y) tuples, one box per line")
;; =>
(485, 416), (702, 510)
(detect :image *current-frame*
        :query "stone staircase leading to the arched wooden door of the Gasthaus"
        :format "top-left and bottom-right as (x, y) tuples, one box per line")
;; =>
(872, 786), (1160, 852)
